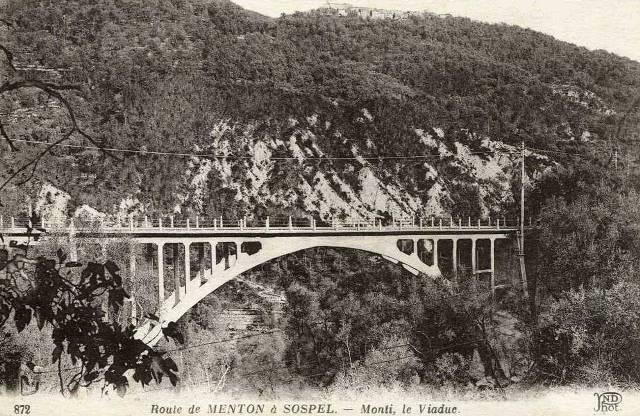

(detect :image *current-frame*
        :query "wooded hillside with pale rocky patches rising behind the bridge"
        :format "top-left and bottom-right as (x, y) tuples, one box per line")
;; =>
(0, 0), (640, 218)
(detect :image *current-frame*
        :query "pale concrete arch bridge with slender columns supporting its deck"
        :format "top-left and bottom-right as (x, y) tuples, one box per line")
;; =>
(0, 217), (519, 346)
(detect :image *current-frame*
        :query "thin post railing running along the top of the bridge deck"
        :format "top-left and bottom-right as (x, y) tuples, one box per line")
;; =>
(0, 215), (532, 231)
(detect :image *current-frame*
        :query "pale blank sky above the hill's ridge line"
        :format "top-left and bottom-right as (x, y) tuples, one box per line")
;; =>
(232, 0), (640, 61)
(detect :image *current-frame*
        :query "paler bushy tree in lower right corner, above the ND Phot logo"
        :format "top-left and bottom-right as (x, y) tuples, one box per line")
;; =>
(537, 282), (640, 385)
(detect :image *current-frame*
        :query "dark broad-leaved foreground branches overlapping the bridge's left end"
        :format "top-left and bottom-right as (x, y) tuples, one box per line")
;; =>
(0, 230), (183, 395)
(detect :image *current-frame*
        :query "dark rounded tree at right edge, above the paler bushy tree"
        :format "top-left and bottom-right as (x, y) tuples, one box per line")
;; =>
(531, 186), (640, 293)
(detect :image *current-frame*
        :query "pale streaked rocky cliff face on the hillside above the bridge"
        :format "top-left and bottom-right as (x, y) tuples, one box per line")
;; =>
(171, 118), (553, 220)
